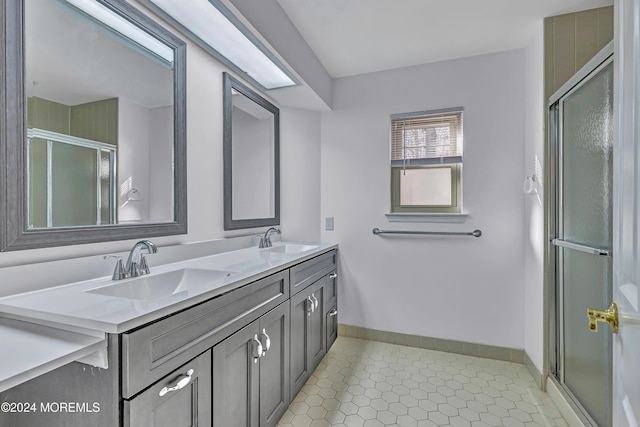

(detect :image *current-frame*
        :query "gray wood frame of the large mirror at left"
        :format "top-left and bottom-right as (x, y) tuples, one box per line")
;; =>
(0, 0), (187, 252)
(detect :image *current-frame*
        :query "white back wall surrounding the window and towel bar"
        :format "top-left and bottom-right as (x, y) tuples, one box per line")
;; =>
(321, 50), (525, 348)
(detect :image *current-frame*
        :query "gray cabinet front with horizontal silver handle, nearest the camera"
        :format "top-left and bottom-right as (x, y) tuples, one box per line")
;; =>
(123, 350), (211, 427)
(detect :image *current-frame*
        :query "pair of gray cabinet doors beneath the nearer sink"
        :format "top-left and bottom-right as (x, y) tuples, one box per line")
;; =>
(213, 302), (290, 427)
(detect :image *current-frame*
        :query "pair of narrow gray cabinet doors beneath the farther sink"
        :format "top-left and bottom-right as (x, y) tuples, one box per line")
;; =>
(290, 277), (326, 396)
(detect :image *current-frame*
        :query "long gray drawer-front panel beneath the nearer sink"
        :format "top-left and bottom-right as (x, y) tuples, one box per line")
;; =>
(122, 270), (289, 398)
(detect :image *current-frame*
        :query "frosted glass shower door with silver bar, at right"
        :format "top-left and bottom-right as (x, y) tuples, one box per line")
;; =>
(554, 60), (613, 426)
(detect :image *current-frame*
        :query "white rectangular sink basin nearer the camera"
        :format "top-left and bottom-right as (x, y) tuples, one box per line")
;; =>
(85, 268), (235, 301)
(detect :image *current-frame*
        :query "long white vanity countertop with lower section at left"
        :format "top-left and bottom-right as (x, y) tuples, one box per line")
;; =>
(0, 242), (337, 392)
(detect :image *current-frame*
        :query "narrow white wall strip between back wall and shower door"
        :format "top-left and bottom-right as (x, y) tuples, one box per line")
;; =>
(521, 23), (546, 373)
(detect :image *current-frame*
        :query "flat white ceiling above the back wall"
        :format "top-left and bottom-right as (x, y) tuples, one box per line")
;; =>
(278, 0), (613, 78)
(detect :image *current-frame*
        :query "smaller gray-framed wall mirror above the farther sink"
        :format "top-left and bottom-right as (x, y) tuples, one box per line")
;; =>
(223, 73), (280, 230)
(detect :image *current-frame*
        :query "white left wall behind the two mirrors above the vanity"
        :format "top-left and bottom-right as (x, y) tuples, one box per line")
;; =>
(0, 1), (320, 290)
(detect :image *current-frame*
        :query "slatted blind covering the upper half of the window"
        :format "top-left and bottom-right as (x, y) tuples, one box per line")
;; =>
(391, 108), (462, 167)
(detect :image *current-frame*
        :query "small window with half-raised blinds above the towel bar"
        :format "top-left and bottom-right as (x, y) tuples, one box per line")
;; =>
(391, 108), (463, 213)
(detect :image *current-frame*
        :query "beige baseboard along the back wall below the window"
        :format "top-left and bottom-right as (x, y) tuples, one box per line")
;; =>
(338, 324), (524, 364)
